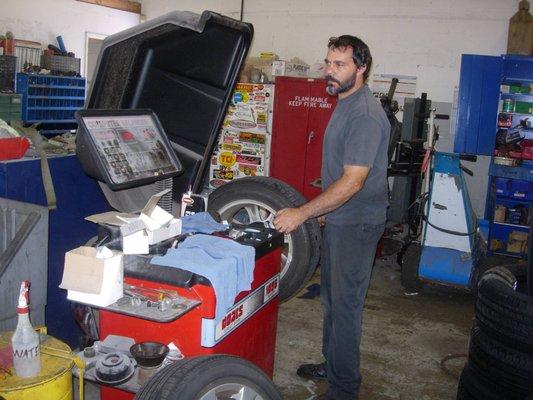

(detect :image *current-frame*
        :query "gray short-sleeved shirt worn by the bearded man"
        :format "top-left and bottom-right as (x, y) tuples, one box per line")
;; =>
(322, 85), (390, 225)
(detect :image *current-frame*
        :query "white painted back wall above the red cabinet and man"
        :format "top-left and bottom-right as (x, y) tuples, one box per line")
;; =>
(142, 0), (518, 103)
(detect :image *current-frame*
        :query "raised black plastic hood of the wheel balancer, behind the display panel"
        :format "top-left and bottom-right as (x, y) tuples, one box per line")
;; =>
(87, 11), (253, 200)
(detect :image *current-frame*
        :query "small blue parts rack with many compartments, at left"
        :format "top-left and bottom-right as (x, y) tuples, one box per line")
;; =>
(17, 74), (85, 124)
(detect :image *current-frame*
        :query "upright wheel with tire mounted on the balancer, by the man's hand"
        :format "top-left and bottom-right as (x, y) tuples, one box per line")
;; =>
(208, 177), (320, 301)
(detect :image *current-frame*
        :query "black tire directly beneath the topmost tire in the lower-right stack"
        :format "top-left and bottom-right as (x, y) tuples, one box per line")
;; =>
(468, 326), (533, 398)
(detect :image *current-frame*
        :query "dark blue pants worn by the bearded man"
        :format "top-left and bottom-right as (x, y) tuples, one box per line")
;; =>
(320, 223), (384, 400)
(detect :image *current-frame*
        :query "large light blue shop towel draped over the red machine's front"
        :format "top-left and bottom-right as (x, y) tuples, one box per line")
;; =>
(151, 235), (255, 323)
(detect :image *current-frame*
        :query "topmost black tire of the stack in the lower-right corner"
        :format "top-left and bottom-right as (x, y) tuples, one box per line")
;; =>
(475, 266), (533, 354)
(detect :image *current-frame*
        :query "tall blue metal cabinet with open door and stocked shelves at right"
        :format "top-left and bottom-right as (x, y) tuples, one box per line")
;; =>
(454, 54), (533, 258)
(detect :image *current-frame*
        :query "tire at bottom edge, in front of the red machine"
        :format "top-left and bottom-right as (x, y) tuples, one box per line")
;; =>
(134, 355), (282, 400)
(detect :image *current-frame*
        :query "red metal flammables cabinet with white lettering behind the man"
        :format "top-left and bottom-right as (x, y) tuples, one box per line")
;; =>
(270, 76), (336, 200)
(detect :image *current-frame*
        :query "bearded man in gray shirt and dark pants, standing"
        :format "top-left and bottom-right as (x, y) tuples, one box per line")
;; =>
(274, 35), (390, 400)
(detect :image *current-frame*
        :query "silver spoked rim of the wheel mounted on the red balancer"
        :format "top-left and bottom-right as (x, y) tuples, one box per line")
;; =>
(214, 199), (294, 277)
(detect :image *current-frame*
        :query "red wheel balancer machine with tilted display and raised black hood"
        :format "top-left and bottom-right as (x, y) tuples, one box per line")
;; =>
(68, 11), (283, 400)
